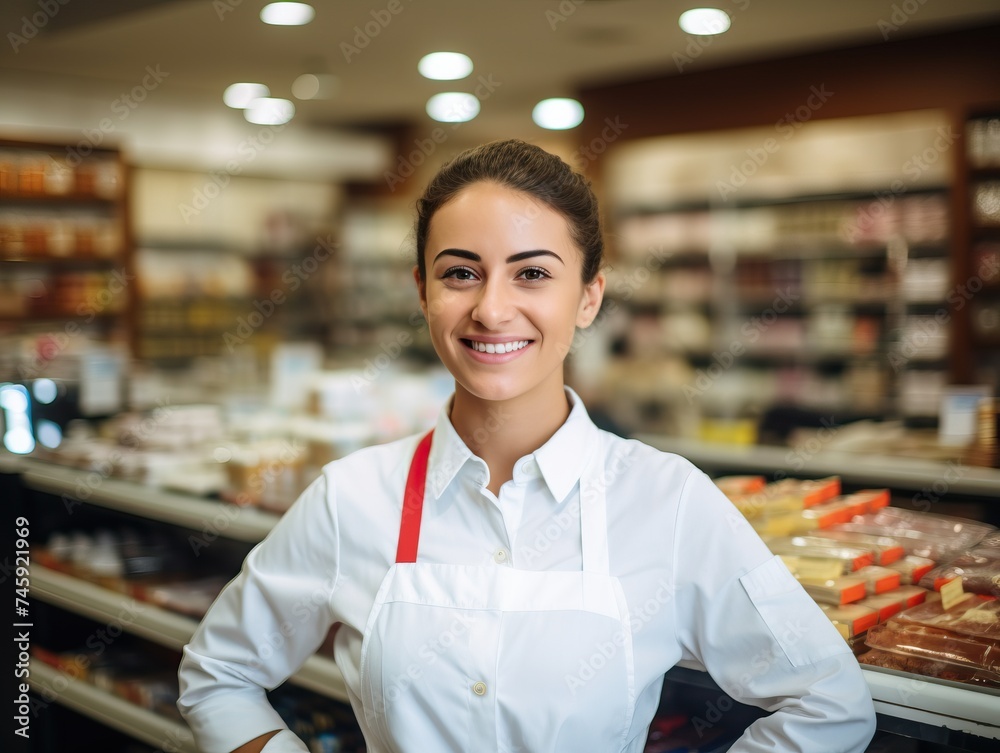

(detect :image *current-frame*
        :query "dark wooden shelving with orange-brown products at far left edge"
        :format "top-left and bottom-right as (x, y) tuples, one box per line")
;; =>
(0, 139), (135, 352)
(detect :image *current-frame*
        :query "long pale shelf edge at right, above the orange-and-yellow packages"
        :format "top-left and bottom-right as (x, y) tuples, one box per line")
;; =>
(636, 435), (1000, 499)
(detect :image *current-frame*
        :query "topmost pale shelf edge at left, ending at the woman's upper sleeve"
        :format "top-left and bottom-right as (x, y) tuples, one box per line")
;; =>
(16, 458), (278, 543)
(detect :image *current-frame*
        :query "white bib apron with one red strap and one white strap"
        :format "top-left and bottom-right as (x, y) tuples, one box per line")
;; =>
(361, 434), (636, 753)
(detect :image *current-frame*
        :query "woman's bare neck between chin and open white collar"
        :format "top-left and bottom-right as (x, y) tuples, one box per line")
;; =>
(450, 381), (570, 495)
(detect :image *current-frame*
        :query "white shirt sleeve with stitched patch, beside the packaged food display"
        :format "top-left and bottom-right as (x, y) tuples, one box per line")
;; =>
(674, 471), (875, 753)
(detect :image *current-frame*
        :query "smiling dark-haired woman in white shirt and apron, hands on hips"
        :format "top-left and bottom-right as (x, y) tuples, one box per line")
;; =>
(179, 141), (874, 753)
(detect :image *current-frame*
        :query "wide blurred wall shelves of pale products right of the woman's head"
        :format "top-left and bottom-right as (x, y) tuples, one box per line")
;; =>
(608, 187), (949, 438)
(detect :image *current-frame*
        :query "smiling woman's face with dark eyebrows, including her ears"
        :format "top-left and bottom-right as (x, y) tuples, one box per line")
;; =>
(414, 183), (604, 400)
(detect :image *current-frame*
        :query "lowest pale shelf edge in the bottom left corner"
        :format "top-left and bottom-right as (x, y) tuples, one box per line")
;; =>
(30, 660), (198, 753)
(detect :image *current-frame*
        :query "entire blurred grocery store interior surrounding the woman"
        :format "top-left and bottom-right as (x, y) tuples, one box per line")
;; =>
(0, 0), (1000, 753)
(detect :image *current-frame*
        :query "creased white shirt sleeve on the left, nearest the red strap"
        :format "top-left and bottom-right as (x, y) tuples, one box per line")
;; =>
(177, 476), (339, 753)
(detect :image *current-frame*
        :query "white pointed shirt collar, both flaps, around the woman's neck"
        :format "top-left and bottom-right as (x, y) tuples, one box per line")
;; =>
(427, 387), (598, 502)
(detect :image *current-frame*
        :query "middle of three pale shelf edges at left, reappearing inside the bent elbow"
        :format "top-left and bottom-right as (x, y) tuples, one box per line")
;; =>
(31, 564), (350, 703)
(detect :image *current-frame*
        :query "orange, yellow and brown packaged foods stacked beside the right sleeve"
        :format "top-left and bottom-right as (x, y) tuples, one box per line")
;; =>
(717, 476), (1000, 687)
